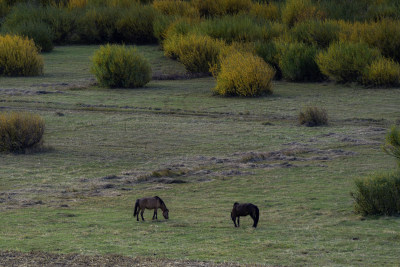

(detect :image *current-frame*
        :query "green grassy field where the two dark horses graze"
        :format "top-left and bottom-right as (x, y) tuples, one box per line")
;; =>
(0, 46), (400, 266)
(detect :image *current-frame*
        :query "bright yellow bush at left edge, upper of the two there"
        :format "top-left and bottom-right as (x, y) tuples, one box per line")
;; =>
(0, 34), (43, 76)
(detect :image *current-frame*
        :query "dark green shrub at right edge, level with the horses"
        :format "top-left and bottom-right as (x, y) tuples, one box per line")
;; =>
(351, 171), (400, 216)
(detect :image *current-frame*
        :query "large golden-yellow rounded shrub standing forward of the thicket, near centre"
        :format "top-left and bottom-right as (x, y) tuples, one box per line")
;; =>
(213, 52), (275, 97)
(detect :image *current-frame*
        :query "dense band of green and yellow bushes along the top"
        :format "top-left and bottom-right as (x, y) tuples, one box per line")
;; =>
(0, 0), (400, 90)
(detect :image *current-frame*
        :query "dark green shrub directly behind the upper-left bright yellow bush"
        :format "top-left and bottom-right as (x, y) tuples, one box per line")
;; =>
(4, 22), (54, 52)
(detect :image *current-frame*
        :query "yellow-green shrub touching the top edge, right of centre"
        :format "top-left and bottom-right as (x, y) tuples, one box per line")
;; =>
(282, 0), (325, 27)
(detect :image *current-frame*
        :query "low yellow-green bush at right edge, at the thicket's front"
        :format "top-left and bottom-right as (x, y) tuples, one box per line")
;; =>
(363, 58), (400, 87)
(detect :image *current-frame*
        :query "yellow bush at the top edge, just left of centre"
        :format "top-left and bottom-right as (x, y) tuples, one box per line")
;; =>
(153, 0), (200, 18)
